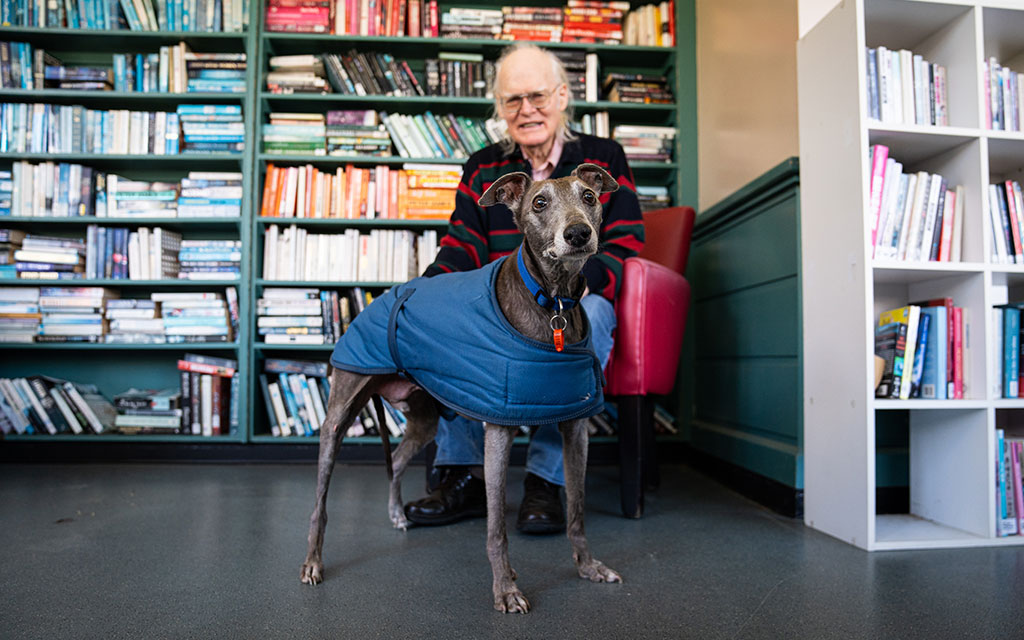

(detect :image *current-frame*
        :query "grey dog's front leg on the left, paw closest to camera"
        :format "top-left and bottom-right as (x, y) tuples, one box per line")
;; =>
(483, 424), (529, 613)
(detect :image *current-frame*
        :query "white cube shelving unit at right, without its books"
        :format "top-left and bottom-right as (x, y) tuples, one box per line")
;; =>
(798, 0), (1024, 550)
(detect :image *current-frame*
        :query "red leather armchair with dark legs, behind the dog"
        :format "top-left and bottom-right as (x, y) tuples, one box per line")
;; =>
(604, 207), (696, 518)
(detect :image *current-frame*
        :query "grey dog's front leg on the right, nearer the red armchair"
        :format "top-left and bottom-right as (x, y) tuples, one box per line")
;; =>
(559, 420), (623, 583)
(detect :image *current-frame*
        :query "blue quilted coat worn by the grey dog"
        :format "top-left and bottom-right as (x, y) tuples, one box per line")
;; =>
(331, 258), (604, 426)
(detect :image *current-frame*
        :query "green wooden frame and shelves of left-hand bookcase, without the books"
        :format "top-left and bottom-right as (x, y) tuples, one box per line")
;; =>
(0, 18), (257, 438)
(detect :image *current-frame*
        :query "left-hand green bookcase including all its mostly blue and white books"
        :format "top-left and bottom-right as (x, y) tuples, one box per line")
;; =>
(0, 0), (256, 442)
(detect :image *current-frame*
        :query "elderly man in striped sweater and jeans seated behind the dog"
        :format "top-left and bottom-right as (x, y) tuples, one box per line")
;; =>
(406, 44), (643, 534)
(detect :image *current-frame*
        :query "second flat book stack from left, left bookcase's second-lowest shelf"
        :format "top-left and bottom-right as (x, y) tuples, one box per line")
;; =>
(36, 287), (118, 342)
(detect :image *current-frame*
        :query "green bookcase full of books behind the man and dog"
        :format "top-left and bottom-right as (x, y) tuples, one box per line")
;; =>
(243, 0), (679, 443)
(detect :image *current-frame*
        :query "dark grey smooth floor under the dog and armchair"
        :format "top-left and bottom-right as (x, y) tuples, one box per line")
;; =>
(0, 464), (1024, 640)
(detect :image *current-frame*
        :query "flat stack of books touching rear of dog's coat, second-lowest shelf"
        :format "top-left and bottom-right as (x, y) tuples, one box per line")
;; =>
(256, 287), (329, 344)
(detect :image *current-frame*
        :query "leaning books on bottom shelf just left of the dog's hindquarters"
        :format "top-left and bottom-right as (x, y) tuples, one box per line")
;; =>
(259, 357), (331, 436)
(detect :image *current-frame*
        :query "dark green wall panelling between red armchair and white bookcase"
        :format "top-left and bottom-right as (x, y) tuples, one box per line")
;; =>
(683, 159), (803, 489)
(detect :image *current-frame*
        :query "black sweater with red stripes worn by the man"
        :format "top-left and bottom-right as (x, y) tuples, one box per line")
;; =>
(423, 133), (644, 301)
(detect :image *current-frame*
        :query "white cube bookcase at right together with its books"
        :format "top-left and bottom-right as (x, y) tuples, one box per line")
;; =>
(798, 0), (1024, 550)
